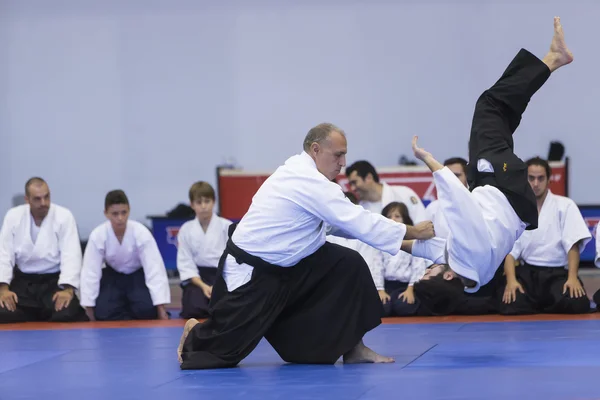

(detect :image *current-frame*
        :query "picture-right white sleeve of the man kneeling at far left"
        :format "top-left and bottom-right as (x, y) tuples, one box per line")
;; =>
(58, 211), (83, 289)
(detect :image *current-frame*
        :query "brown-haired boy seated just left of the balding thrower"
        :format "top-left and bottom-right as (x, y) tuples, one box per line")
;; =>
(177, 182), (231, 318)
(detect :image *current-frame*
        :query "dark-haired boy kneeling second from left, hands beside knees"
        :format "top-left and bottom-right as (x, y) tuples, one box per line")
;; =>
(81, 190), (171, 321)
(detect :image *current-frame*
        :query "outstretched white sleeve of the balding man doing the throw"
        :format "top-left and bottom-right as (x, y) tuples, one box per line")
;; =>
(293, 177), (406, 254)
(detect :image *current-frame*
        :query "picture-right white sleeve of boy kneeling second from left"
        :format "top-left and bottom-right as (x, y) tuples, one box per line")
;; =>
(139, 230), (171, 306)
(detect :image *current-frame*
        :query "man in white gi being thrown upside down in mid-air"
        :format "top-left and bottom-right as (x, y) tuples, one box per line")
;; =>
(402, 17), (573, 307)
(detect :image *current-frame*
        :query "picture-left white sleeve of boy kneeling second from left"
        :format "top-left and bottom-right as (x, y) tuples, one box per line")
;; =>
(79, 232), (104, 307)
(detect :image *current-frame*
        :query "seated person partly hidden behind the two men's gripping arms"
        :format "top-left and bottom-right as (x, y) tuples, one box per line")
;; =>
(374, 201), (428, 317)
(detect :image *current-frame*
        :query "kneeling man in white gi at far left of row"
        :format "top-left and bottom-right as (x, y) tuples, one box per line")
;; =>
(0, 177), (87, 322)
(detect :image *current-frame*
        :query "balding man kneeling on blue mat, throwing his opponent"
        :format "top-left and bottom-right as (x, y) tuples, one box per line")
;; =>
(178, 124), (434, 369)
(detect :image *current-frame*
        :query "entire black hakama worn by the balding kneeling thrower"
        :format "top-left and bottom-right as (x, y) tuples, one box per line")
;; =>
(181, 243), (382, 369)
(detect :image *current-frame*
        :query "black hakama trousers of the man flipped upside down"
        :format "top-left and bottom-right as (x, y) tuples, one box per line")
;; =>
(468, 49), (550, 229)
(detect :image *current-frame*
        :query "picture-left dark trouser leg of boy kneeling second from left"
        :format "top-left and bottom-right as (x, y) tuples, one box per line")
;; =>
(94, 267), (132, 321)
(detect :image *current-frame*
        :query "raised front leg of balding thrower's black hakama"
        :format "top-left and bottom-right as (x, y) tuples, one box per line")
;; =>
(265, 244), (383, 364)
